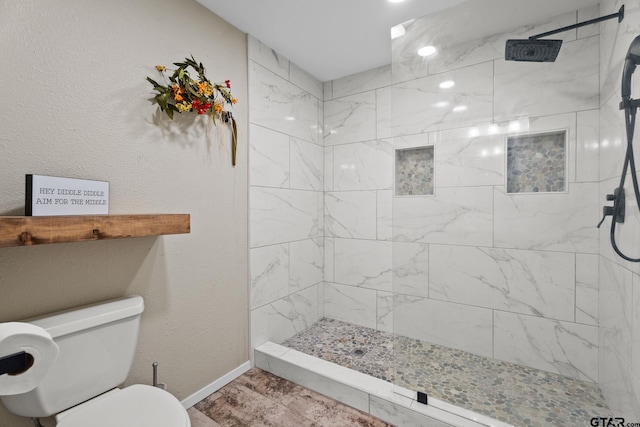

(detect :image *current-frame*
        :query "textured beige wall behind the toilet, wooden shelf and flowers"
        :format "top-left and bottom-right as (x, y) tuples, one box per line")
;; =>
(0, 0), (248, 427)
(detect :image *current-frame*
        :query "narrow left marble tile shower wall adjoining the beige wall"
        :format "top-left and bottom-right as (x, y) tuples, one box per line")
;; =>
(249, 36), (322, 355)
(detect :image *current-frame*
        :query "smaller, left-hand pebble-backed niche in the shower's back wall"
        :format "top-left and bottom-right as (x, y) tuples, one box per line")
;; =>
(395, 145), (434, 196)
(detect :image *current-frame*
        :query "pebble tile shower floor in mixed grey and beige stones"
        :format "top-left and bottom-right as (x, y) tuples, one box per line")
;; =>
(283, 318), (612, 426)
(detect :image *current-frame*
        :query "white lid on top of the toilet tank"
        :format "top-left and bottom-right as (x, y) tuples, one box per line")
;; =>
(25, 295), (144, 338)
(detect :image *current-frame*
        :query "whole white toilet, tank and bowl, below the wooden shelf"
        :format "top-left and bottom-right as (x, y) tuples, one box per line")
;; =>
(0, 296), (191, 427)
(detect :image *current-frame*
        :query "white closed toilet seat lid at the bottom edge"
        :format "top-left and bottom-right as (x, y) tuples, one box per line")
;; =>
(56, 384), (191, 427)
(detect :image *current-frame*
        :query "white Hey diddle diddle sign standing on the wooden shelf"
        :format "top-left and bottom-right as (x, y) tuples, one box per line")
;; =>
(25, 174), (109, 216)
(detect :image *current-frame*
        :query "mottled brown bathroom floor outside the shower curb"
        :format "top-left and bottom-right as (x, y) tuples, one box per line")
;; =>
(189, 368), (389, 427)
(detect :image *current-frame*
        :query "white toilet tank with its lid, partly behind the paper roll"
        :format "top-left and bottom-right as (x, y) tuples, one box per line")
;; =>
(1, 296), (144, 417)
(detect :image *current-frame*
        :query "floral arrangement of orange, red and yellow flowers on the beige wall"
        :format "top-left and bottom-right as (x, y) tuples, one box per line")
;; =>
(147, 55), (238, 166)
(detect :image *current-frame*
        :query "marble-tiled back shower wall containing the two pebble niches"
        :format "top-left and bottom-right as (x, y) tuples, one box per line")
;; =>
(324, 7), (601, 382)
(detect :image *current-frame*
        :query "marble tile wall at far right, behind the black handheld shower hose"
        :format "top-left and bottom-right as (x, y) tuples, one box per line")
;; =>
(596, 0), (640, 420)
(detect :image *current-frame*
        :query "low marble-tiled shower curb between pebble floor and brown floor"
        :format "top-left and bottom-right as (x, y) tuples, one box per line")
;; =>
(254, 342), (513, 427)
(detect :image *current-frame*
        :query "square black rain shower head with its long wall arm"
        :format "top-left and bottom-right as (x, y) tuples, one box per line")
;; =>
(504, 5), (624, 62)
